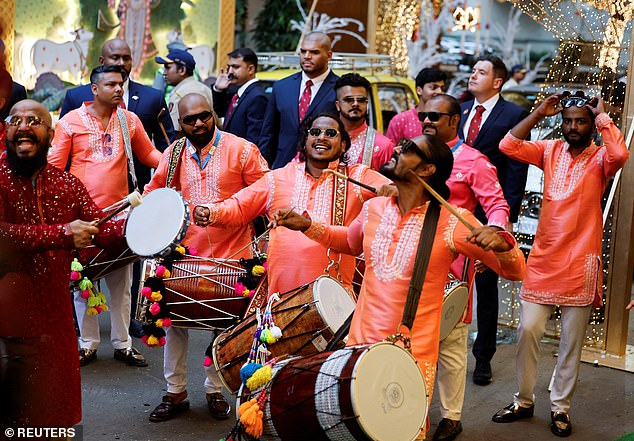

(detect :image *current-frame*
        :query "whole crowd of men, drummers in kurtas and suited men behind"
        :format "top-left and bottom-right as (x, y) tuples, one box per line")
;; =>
(0, 32), (628, 440)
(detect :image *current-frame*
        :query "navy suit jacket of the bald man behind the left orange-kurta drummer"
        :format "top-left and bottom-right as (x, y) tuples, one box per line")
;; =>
(59, 80), (175, 186)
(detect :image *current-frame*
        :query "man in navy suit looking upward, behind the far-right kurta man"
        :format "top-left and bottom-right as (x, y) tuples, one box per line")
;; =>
(458, 55), (528, 385)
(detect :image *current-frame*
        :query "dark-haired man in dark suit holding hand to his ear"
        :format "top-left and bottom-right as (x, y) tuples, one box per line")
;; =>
(212, 47), (268, 144)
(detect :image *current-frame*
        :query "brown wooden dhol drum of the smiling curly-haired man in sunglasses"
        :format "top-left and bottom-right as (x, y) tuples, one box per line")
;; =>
(213, 276), (355, 393)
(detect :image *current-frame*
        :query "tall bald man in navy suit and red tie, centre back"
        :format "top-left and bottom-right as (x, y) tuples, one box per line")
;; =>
(257, 32), (339, 169)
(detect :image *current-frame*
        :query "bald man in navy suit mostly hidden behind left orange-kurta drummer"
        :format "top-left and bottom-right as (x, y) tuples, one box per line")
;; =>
(59, 38), (174, 187)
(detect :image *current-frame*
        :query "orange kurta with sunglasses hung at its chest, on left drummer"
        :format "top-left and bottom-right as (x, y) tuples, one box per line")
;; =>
(48, 103), (161, 208)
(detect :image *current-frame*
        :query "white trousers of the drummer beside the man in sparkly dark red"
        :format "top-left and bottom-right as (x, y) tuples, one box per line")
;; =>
(74, 265), (132, 349)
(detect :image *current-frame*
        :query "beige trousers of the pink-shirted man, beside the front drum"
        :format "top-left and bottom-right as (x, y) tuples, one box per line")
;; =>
(436, 322), (469, 421)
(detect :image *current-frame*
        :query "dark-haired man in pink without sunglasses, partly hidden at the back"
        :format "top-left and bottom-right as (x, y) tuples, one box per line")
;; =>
(385, 67), (447, 143)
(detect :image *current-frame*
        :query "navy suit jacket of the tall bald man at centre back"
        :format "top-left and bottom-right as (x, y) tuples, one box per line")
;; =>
(257, 71), (339, 168)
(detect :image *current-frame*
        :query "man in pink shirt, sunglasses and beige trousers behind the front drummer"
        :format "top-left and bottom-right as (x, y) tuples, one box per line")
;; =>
(414, 95), (509, 441)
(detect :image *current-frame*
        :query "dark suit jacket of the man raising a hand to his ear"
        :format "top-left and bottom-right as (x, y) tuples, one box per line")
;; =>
(212, 81), (268, 145)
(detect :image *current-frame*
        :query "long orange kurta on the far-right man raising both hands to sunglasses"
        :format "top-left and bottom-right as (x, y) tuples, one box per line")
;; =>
(500, 113), (629, 306)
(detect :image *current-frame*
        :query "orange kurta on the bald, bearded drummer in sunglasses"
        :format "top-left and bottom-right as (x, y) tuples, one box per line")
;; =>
(144, 129), (268, 259)
